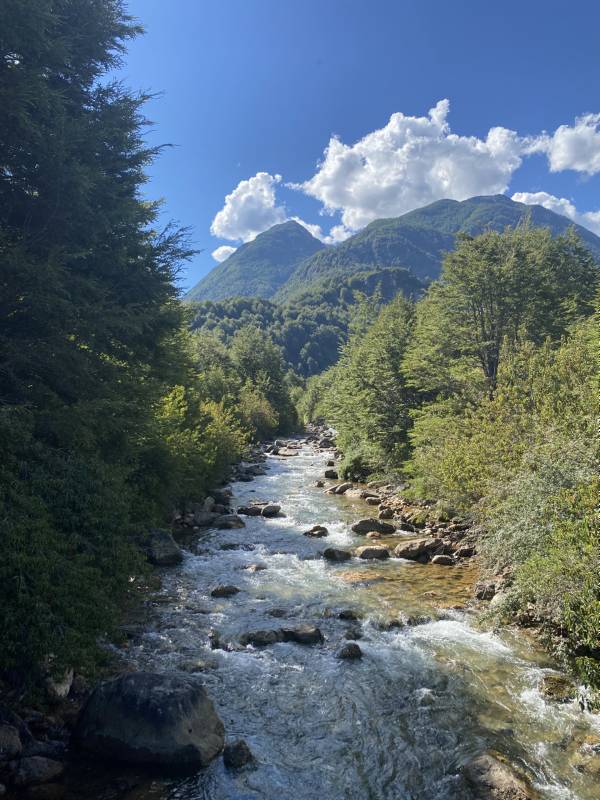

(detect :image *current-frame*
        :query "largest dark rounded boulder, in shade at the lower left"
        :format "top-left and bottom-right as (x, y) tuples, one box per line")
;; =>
(73, 672), (224, 769)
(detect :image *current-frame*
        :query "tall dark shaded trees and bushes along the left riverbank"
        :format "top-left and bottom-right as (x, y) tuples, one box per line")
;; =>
(0, 0), (295, 679)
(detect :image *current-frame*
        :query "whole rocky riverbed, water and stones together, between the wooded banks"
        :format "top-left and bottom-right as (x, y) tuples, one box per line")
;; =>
(0, 432), (600, 800)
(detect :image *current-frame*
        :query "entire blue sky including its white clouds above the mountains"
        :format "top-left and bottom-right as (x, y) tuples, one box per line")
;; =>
(120, 0), (600, 288)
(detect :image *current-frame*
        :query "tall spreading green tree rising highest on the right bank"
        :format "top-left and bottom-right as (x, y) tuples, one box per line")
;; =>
(406, 225), (598, 395)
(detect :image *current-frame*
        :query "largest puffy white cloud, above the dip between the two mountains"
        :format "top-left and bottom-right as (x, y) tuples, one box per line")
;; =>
(294, 100), (524, 235)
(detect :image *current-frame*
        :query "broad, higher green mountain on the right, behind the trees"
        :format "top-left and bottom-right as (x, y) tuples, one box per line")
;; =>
(275, 195), (600, 301)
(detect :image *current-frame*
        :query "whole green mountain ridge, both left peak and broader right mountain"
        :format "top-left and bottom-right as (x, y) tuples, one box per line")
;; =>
(186, 195), (600, 302)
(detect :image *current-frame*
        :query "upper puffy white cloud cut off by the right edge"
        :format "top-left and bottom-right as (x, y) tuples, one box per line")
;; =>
(530, 114), (600, 175)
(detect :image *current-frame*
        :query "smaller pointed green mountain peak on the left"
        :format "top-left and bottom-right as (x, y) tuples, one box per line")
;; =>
(186, 221), (324, 300)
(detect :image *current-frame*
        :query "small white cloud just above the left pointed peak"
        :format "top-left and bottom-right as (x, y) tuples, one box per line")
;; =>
(210, 172), (287, 242)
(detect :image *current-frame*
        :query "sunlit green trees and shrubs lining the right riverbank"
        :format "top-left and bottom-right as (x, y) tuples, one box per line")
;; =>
(301, 225), (600, 684)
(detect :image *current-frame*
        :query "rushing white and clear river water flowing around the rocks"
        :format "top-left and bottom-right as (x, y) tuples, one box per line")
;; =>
(77, 446), (600, 800)
